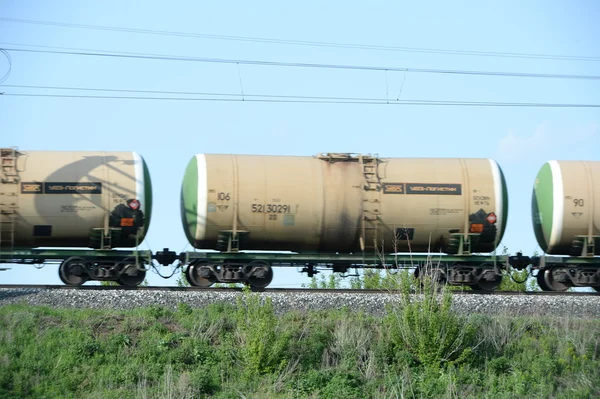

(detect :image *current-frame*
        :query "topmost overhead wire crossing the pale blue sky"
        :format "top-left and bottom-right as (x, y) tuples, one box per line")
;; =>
(0, 17), (600, 62)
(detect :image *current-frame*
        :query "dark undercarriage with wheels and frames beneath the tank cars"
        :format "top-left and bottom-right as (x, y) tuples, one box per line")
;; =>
(7, 248), (600, 292)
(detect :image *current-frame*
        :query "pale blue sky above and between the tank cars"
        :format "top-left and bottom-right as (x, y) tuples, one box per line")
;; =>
(0, 0), (600, 287)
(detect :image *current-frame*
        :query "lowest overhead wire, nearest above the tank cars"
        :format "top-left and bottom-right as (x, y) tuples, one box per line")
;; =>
(0, 93), (600, 108)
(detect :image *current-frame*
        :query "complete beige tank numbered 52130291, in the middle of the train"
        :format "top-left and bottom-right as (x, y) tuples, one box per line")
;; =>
(181, 154), (508, 253)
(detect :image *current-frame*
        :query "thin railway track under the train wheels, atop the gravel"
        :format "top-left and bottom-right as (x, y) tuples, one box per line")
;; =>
(0, 284), (600, 296)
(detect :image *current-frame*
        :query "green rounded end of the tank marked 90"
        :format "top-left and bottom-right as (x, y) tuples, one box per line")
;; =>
(531, 162), (554, 252)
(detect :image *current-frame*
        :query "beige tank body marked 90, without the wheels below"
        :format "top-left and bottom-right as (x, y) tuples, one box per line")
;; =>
(531, 160), (600, 255)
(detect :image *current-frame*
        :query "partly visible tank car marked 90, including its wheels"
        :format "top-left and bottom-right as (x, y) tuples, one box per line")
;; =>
(531, 160), (600, 291)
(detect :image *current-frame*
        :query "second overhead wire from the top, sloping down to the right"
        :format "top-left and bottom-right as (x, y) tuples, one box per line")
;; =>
(3, 47), (600, 80)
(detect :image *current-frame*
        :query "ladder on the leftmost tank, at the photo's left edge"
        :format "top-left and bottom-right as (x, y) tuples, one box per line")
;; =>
(0, 148), (20, 260)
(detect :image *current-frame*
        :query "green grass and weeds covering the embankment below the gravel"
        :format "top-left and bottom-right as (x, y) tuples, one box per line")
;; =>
(0, 284), (600, 399)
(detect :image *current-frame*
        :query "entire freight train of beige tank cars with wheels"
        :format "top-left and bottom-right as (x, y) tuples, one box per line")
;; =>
(0, 148), (600, 291)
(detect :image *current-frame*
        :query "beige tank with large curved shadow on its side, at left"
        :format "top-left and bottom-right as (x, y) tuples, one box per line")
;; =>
(0, 149), (152, 250)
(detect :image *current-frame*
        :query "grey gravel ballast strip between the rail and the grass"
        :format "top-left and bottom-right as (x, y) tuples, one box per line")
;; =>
(0, 288), (600, 318)
